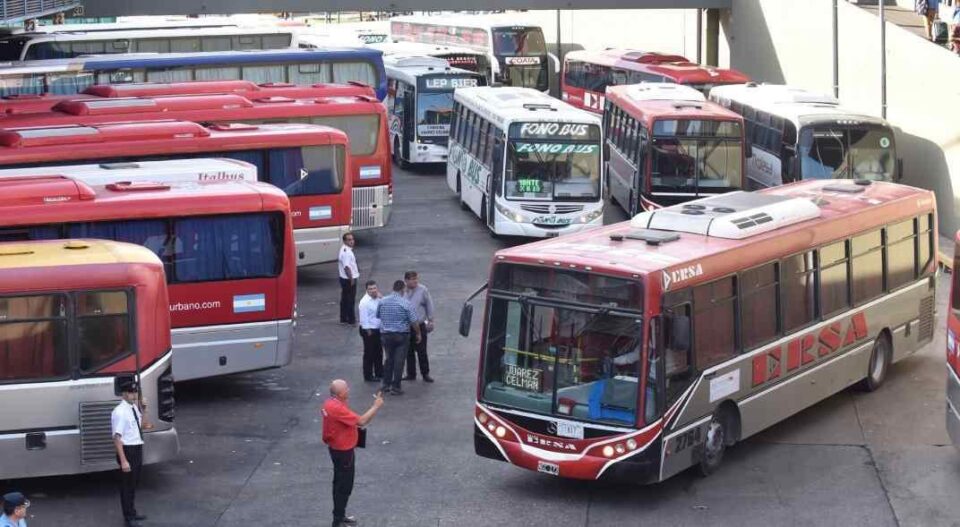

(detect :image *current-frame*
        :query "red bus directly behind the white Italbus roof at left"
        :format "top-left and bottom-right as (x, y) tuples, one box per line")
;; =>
(0, 121), (351, 265)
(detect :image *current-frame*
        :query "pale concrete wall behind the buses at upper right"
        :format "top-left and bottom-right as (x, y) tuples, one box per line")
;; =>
(723, 0), (960, 235)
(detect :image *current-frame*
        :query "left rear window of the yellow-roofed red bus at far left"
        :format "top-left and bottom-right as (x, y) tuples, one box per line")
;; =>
(0, 295), (70, 382)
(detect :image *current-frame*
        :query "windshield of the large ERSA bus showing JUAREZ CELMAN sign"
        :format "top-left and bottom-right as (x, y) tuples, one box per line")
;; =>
(482, 265), (643, 432)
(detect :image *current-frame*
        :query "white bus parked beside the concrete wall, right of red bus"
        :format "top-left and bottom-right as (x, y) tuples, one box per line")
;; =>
(710, 83), (902, 190)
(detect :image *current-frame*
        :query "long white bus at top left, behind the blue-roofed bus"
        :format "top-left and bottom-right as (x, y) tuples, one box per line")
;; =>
(0, 27), (296, 61)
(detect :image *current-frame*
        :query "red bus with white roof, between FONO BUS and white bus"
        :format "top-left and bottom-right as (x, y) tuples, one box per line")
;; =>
(603, 82), (744, 216)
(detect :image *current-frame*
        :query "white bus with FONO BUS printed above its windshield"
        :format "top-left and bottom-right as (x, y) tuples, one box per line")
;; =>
(447, 87), (603, 237)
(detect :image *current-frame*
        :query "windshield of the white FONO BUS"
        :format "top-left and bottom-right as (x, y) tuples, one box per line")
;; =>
(504, 123), (601, 201)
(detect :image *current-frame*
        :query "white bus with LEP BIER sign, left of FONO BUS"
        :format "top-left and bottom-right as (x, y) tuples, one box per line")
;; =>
(383, 55), (486, 167)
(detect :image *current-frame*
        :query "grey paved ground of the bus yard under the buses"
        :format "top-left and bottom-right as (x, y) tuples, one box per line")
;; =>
(7, 166), (960, 527)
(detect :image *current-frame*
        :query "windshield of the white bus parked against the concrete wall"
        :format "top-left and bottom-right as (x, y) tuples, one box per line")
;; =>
(798, 126), (896, 181)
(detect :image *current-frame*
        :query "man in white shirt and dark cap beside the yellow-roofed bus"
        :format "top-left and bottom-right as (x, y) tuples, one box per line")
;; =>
(110, 379), (147, 527)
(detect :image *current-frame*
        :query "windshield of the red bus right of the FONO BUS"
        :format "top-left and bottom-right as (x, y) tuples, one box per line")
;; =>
(651, 119), (743, 193)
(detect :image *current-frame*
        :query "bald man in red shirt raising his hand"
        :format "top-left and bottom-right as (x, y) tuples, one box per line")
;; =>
(320, 379), (383, 527)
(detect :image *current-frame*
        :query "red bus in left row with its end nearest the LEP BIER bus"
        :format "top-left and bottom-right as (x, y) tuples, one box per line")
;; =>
(0, 81), (393, 230)
